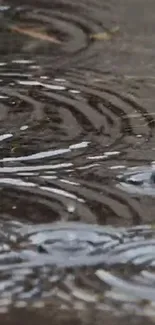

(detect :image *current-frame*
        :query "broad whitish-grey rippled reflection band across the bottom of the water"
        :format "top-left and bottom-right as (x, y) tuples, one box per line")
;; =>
(0, 220), (155, 315)
